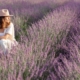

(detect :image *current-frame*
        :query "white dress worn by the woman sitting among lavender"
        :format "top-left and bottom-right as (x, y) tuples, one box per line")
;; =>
(0, 22), (18, 54)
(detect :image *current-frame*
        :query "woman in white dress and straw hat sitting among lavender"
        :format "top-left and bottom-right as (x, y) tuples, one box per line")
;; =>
(0, 9), (17, 54)
